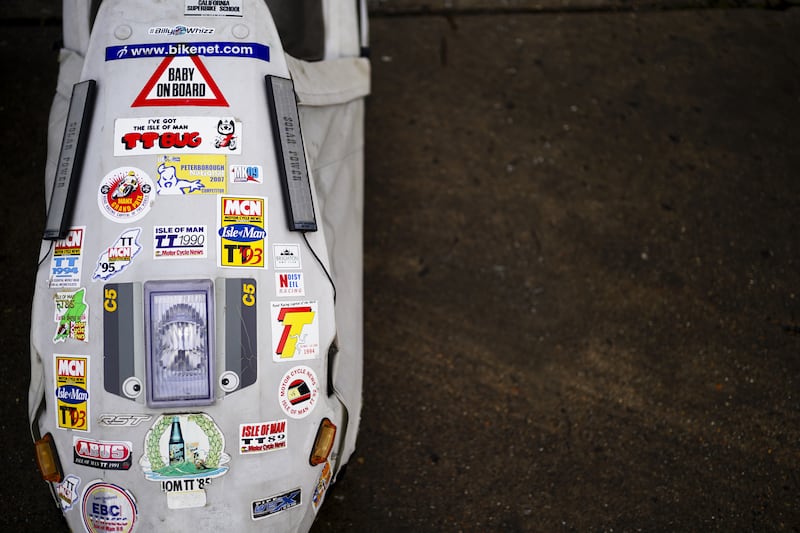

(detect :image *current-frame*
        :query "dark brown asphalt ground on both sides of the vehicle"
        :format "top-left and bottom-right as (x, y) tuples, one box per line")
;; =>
(0, 8), (800, 532)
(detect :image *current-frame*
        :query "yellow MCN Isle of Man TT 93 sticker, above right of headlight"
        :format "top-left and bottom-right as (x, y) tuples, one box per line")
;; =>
(217, 196), (267, 268)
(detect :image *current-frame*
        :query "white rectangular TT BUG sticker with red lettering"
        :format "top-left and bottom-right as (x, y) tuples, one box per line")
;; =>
(114, 117), (242, 156)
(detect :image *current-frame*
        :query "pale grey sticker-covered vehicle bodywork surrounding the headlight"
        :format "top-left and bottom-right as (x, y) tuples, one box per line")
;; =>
(29, 0), (369, 531)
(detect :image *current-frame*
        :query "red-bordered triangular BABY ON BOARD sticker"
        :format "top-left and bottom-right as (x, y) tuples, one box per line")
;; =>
(131, 56), (228, 107)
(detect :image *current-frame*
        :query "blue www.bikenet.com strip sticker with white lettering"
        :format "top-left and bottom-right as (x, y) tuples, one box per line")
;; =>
(106, 41), (269, 62)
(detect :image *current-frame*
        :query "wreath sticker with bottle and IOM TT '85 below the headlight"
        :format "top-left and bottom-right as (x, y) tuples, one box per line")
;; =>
(139, 413), (231, 509)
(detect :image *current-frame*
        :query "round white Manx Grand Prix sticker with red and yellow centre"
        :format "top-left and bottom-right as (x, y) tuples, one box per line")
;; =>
(97, 167), (154, 223)
